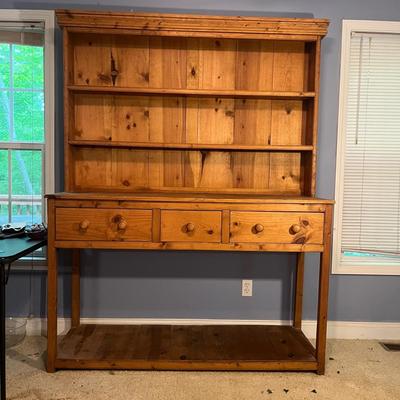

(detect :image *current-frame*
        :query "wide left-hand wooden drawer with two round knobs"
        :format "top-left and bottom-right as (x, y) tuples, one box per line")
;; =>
(56, 208), (152, 241)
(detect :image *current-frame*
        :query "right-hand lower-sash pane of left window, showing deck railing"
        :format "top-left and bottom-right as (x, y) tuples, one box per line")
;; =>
(11, 150), (42, 223)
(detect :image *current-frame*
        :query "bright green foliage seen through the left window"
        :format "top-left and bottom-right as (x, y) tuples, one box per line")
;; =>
(0, 43), (44, 223)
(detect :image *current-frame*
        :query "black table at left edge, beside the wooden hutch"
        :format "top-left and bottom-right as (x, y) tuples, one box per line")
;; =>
(0, 237), (47, 400)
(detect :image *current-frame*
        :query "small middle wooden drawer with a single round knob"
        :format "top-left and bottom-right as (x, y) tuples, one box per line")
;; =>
(161, 210), (221, 243)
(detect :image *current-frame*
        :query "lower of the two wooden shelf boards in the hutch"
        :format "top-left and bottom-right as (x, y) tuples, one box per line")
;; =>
(68, 140), (314, 152)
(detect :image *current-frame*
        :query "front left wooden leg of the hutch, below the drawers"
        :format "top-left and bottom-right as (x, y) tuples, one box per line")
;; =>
(47, 246), (57, 372)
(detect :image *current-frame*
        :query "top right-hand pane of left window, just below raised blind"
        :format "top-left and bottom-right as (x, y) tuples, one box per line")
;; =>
(12, 45), (44, 89)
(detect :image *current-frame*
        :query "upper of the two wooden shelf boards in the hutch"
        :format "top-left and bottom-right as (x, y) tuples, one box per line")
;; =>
(67, 85), (315, 99)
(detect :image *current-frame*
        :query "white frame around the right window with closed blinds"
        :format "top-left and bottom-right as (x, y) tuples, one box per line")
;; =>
(332, 20), (400, 275)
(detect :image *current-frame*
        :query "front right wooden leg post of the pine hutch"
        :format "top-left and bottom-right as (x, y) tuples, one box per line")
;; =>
(316, 207), (332, 375)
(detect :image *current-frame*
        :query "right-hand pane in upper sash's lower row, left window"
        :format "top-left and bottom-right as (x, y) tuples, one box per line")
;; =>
(13, 91), (44, 142)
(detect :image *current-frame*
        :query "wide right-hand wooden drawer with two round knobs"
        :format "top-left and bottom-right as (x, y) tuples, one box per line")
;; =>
(230, 211), (324, 244)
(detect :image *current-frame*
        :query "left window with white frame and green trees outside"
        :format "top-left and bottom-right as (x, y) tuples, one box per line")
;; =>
(0, 10), (54, 234)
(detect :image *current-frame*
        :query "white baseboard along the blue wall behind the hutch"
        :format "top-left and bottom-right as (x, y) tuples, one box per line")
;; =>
(23, 318), (400, 340)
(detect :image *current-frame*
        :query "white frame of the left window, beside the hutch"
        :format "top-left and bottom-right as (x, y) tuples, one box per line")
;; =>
(0, 9), (55, 221)
